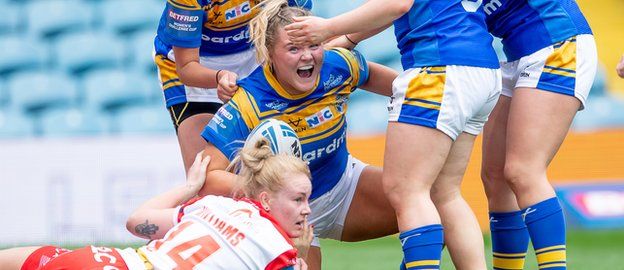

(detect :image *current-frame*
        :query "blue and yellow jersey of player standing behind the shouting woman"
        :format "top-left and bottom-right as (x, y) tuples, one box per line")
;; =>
(154, 0), (312, 56)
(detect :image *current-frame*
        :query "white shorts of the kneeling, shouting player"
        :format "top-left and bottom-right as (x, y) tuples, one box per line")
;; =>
(309, 155), (368, 247)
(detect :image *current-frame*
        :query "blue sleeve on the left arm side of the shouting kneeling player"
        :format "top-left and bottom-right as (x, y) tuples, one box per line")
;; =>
(201, 101), (250, 160)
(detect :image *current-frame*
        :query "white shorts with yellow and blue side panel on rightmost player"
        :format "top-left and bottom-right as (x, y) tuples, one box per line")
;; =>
(501, 35), (598, 110)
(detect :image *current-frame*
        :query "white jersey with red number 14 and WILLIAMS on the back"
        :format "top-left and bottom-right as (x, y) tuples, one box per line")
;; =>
(139, 195), (297, 270)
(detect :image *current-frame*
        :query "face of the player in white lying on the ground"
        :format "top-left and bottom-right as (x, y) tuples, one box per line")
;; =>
(268, 173), (312, 237)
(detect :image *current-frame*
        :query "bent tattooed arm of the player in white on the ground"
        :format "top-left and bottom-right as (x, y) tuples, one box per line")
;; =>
(126, 153), (210, 239)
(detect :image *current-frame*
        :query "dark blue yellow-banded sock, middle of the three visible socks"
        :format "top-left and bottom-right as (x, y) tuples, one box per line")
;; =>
(490, 211), (529, 270)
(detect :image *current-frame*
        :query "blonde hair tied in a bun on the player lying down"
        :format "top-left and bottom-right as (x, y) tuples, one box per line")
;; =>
(227, 138), (311, 198)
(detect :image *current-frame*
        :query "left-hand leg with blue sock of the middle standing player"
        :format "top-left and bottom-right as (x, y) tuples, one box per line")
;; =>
(383, 122), (452, 269)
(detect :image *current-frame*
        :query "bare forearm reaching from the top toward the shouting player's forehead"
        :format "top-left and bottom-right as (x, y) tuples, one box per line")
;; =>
(329, 0), (413, 37)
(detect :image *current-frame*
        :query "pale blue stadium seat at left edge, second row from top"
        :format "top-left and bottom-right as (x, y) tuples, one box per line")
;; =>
(0, 35), (47, 75)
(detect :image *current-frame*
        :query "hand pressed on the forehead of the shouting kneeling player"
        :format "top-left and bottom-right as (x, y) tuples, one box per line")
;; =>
(284, 16), (334, 45)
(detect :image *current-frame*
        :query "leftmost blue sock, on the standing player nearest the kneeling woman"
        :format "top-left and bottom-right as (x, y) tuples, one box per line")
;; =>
(399, 224), (444, 270)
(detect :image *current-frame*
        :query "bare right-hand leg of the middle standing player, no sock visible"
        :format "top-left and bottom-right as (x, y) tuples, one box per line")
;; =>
(431, 132), (487, 270)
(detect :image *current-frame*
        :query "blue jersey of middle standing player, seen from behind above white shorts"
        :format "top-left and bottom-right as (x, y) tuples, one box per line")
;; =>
(394, 0), (499, 69)
